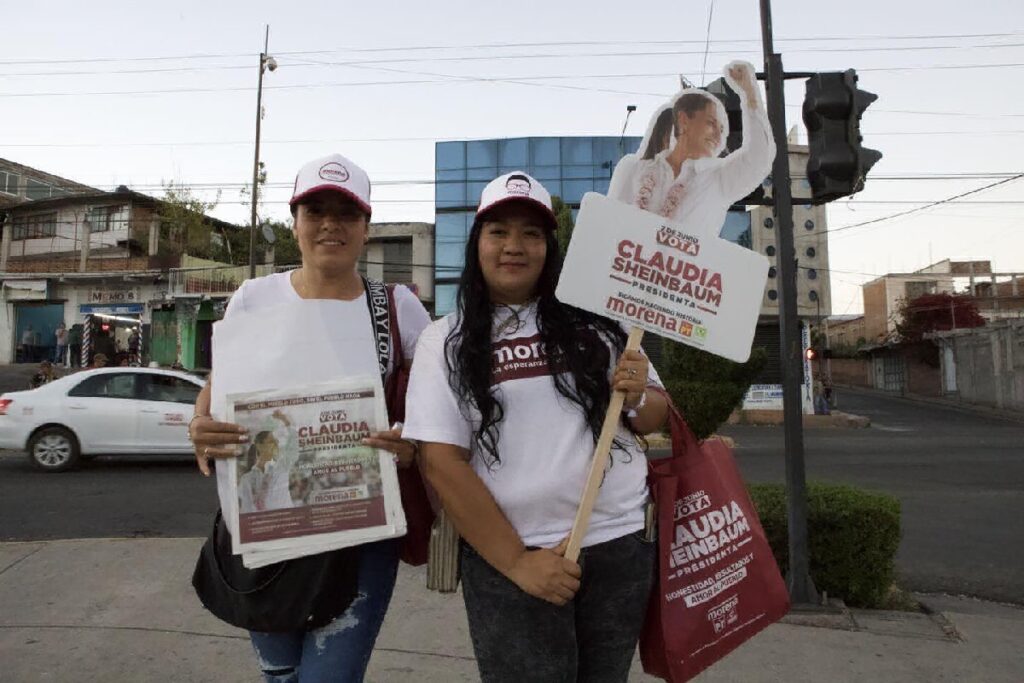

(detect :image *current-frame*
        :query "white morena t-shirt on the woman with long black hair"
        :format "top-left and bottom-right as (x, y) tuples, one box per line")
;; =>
(402, 305), (659, 547)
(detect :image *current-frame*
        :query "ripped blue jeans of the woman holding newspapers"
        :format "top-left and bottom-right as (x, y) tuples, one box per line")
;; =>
(249, 540), (399, 683)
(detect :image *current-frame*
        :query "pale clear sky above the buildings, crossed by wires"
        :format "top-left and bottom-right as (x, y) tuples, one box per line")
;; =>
(0, 0), (1024, 314)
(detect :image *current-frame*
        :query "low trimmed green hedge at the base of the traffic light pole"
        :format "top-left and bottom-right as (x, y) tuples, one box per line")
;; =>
(749, 483), (900, 607)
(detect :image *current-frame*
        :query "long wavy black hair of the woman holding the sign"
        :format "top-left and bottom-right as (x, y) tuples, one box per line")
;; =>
(444, 211), (632, 466)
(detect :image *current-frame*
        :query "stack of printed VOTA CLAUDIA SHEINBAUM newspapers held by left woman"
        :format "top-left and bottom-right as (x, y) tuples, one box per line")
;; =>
(227, 377), (404, 566)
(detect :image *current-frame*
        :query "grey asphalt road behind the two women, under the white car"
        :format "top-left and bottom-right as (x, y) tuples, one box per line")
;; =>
(0, 391), (1024, 603)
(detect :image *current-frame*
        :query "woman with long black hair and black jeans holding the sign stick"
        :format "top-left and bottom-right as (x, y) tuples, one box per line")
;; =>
(403, 172), (668, 683)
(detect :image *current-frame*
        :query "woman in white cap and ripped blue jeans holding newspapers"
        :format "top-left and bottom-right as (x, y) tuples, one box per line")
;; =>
(189, 155), (430, 682)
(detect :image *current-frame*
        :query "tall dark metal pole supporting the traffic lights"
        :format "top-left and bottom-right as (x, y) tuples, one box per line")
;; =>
(761, 0), (818, 605)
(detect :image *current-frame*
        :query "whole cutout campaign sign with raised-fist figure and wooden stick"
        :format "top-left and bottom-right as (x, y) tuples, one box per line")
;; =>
(555, 61), (775, 560)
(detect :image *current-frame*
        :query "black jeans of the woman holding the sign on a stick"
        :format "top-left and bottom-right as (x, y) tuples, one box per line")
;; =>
(461, 531), (656, 683)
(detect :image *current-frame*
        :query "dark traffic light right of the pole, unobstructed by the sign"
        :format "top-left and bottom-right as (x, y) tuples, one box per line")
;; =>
(804, 69), (882, 204)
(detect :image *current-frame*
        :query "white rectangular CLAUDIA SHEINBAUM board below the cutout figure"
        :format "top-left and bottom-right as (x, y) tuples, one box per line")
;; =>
(555, 193), (768, 362)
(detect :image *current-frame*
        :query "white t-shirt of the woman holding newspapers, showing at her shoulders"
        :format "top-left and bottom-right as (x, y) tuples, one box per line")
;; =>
(224, 272), (430, 373)
